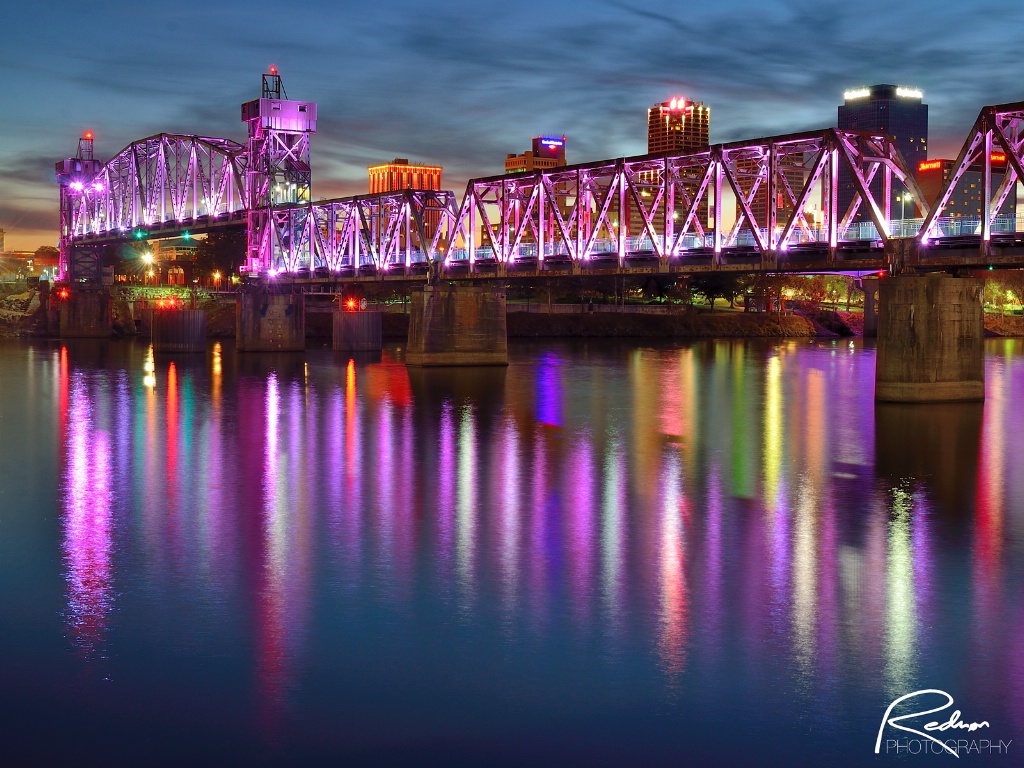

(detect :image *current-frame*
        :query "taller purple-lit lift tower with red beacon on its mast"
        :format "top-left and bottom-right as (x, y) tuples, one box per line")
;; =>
(242, 67), (316, 272)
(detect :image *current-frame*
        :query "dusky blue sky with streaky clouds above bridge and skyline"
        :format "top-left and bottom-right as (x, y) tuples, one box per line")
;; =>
(0, 0), (1024, 250)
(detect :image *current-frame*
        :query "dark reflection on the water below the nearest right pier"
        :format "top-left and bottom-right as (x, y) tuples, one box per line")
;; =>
(874, 402), (984, 518)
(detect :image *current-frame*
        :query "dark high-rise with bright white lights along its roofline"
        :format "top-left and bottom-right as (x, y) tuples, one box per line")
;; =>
(837, 84), (928, 221)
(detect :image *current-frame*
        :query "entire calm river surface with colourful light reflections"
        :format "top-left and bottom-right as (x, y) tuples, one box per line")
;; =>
(0, 340), (1024, 766)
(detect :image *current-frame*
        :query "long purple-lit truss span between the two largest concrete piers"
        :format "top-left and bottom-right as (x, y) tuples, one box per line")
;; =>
(445, 129), (928, 268)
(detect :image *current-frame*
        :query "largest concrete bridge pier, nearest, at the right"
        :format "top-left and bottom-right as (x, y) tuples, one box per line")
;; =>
(874, 274), (985, 402)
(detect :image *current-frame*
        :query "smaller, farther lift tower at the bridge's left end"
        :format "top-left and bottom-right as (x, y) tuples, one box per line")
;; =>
(56, 131), (103, 286)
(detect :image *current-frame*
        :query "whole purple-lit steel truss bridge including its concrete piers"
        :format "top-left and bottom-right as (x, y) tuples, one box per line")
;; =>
(57, 70), (1024, 401)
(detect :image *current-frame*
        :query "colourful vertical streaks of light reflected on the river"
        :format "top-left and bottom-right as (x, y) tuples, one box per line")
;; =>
(37, 342), (1024, 765)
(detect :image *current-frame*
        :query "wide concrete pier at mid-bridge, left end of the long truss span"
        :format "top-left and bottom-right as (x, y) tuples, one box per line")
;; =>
(406, 286), (509, 366)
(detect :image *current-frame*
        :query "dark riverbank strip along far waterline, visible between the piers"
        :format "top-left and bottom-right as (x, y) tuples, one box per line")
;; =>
(0, 287), (1024, 339)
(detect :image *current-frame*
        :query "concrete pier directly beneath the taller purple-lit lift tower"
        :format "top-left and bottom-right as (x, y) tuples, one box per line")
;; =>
(234, 293), (306, 352)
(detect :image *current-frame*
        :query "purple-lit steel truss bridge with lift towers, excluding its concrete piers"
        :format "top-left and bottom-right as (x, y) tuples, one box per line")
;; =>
(57, 72), (1024, 284)
